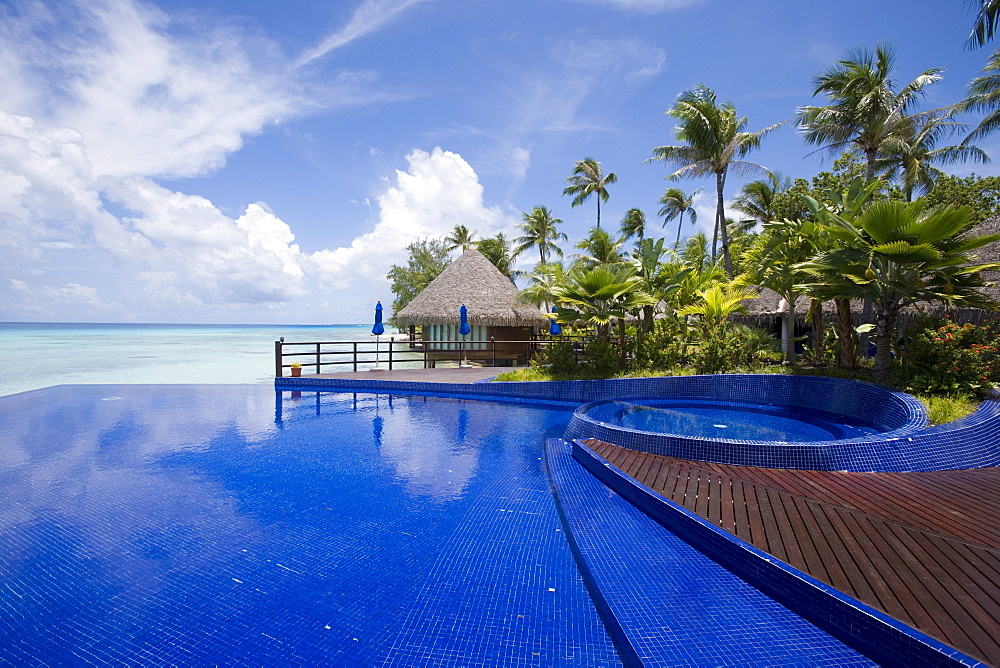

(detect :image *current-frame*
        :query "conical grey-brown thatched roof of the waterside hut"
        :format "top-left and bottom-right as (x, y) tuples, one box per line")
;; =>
(396, 248), (549, 327)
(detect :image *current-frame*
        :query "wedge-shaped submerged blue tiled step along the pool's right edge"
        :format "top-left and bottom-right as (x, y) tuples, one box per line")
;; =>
(546, 439), (874, 666)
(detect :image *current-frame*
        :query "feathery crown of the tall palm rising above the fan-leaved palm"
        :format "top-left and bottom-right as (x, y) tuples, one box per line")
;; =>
(797, 44), (942, 181)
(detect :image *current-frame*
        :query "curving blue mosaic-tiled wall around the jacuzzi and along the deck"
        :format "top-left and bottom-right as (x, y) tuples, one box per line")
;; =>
(275, 374), (1000, 471)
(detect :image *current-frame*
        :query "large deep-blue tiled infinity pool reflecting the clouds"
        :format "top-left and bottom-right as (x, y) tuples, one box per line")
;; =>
(0, 385), (870, 666)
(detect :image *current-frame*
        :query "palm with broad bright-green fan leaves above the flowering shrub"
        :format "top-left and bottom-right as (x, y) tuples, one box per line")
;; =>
(800, 200), (1000, 376)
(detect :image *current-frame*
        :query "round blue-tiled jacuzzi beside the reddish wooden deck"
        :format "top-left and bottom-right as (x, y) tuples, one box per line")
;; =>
(565, 375), (927, 470)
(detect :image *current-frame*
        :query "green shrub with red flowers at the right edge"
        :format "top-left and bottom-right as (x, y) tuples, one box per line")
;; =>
(900, 316), (1000, 394)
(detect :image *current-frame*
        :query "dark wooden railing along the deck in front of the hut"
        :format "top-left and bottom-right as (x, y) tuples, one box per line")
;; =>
(274, 337), (576, 378)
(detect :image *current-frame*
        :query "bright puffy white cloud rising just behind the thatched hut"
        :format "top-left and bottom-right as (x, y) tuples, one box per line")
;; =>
(312, 148), (508, 286)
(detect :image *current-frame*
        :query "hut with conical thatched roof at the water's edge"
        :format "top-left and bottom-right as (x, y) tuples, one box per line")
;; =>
(396, 248), (549, 366)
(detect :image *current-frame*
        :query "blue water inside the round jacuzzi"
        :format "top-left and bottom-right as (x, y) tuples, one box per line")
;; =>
(613, 399), (879, 442)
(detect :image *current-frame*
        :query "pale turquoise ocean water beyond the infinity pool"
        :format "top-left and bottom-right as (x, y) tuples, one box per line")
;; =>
(0, 323), (402, 395)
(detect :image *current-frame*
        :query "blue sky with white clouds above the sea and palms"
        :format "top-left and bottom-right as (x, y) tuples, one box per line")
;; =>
(0, 0), (1000, 324)
